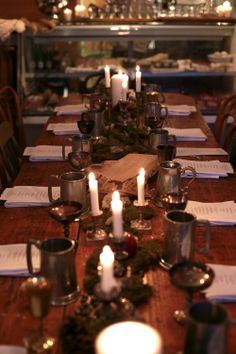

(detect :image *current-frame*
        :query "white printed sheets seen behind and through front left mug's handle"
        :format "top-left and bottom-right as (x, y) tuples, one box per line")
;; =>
(0, 243), (40, 276)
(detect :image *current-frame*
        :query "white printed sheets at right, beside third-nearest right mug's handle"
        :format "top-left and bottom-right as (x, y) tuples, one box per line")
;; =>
(174, 159), (234, 178)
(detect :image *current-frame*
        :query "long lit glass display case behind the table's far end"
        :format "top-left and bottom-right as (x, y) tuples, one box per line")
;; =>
(19, 21), (236, 116)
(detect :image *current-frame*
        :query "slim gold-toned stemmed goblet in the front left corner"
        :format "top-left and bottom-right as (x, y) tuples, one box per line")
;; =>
(22, 276), (55, 353)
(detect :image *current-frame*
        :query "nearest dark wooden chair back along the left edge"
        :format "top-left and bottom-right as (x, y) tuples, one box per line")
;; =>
(0, 120), (23, 188)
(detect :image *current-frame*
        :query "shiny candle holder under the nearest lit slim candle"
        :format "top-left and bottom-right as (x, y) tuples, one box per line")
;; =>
(94, 281), (135, 319)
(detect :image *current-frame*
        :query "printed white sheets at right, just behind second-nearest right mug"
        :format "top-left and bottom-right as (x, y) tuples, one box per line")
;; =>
(185, 200), (236, 226)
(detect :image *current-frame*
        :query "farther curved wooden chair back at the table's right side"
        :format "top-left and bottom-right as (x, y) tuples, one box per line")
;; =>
(214, 94), (236, 146)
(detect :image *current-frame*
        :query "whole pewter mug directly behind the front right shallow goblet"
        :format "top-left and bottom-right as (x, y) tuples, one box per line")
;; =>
(160, 210), (210, 269)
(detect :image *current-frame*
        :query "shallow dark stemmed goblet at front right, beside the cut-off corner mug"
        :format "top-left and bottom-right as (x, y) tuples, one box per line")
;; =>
(169, 260), (214, 324)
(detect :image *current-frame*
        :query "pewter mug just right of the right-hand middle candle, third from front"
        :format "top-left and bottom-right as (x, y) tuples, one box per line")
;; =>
(156, 161), (196, 206)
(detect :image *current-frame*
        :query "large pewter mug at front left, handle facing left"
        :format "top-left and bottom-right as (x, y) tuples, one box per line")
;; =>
(26, 237), (79, 305)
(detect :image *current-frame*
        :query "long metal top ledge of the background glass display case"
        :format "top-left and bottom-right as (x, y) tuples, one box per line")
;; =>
(26, 21), (234, 44)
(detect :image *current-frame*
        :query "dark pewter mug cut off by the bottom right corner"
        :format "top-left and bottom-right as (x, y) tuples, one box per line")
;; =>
(184, 301), (236, 354)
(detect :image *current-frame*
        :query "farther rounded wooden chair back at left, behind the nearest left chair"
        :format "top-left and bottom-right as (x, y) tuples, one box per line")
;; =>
(0, 86), (26, 149)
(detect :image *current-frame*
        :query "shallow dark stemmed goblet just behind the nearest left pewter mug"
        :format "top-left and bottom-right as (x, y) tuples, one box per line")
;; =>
(48, 201), (82, 238)
